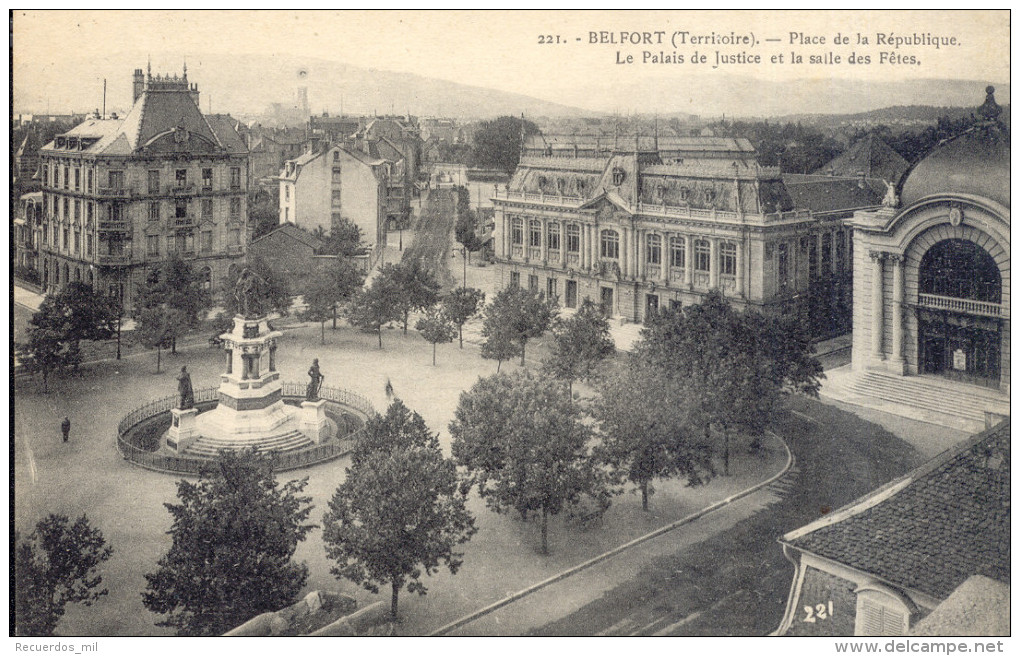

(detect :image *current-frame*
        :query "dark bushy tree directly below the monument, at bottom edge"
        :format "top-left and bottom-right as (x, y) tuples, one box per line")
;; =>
(142, 451), (314, 636)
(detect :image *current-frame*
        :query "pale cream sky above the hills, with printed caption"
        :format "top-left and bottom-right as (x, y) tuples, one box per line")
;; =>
(12, 10), (1010, 111)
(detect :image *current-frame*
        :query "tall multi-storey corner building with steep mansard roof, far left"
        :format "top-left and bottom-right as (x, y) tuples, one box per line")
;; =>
(36, 69), (248, 308)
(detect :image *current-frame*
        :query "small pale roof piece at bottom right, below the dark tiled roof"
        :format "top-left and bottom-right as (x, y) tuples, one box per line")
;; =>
(910, 575), (1010, 637)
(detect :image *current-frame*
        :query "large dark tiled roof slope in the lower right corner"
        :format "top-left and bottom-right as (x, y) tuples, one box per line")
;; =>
(780, 419), (1010, 599)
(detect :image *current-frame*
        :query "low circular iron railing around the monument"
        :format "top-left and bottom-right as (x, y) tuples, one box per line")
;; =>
(117, 383), (375, 475)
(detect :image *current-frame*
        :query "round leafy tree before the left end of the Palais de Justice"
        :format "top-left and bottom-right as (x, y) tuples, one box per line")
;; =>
(481, 287), (557, 366)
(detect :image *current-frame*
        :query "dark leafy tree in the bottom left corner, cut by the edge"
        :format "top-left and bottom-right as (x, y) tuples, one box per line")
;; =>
(14, 514), (113, 637)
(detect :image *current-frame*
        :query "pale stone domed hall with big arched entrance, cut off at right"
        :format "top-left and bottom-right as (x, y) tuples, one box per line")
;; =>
(853, 87), (1010, 400)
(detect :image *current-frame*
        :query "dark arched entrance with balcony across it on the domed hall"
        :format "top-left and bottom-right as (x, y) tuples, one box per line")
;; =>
(917, 239), (1003, 388)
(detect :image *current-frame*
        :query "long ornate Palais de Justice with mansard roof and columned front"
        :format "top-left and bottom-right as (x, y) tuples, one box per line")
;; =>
(493, 137), (864, 321)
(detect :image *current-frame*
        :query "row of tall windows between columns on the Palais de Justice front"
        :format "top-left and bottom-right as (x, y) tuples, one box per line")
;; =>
(510, 218), (736, 275)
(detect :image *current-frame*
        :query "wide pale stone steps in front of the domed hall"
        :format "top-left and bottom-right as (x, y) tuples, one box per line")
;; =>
(853, 371), (1010, 424)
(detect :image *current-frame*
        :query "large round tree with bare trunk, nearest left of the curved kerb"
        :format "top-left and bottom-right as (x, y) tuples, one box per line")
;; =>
(450, 371), (609, 554)
